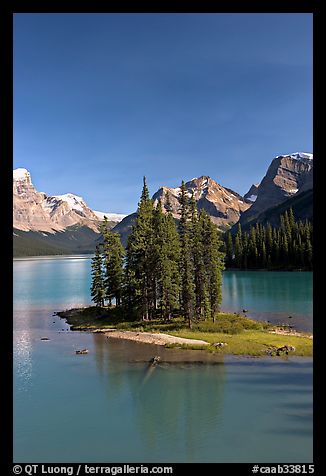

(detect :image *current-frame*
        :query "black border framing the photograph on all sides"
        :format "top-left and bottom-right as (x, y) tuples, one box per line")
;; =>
(0, 0), (320, 475)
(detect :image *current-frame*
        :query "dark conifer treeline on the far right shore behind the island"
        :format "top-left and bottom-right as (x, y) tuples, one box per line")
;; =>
(224, 208), (313, 271)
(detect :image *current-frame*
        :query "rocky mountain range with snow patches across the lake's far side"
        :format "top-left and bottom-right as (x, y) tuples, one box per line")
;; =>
(13, 152), (313, 255)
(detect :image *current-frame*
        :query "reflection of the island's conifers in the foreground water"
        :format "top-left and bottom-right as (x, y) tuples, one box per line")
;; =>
(94, 336), (226, 461)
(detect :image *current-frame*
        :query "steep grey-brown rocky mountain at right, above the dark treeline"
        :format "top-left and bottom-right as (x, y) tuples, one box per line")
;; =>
(240, 152), (313, 226)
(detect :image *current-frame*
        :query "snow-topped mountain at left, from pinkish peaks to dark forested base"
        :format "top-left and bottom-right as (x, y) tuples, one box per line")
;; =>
(13, 168), (125, 256)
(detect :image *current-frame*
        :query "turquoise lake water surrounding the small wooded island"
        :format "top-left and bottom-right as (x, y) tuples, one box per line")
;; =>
(14, 257), (312, 463)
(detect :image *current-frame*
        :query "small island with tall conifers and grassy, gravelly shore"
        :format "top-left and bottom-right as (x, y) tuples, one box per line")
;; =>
(57, 177), (313, 357)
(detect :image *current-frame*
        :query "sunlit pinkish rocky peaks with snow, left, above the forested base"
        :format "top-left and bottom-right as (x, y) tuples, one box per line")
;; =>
(13, 168), (122, 233)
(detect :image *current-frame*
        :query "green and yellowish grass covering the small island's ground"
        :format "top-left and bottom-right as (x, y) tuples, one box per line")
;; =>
(58, 306), (313, 357)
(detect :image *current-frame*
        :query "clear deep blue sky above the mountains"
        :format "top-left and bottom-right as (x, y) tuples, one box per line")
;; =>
(14, 13), (312, 213)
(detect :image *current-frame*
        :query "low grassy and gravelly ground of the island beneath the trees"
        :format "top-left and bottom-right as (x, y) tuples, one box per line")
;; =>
(56, 307), (313, 357)
